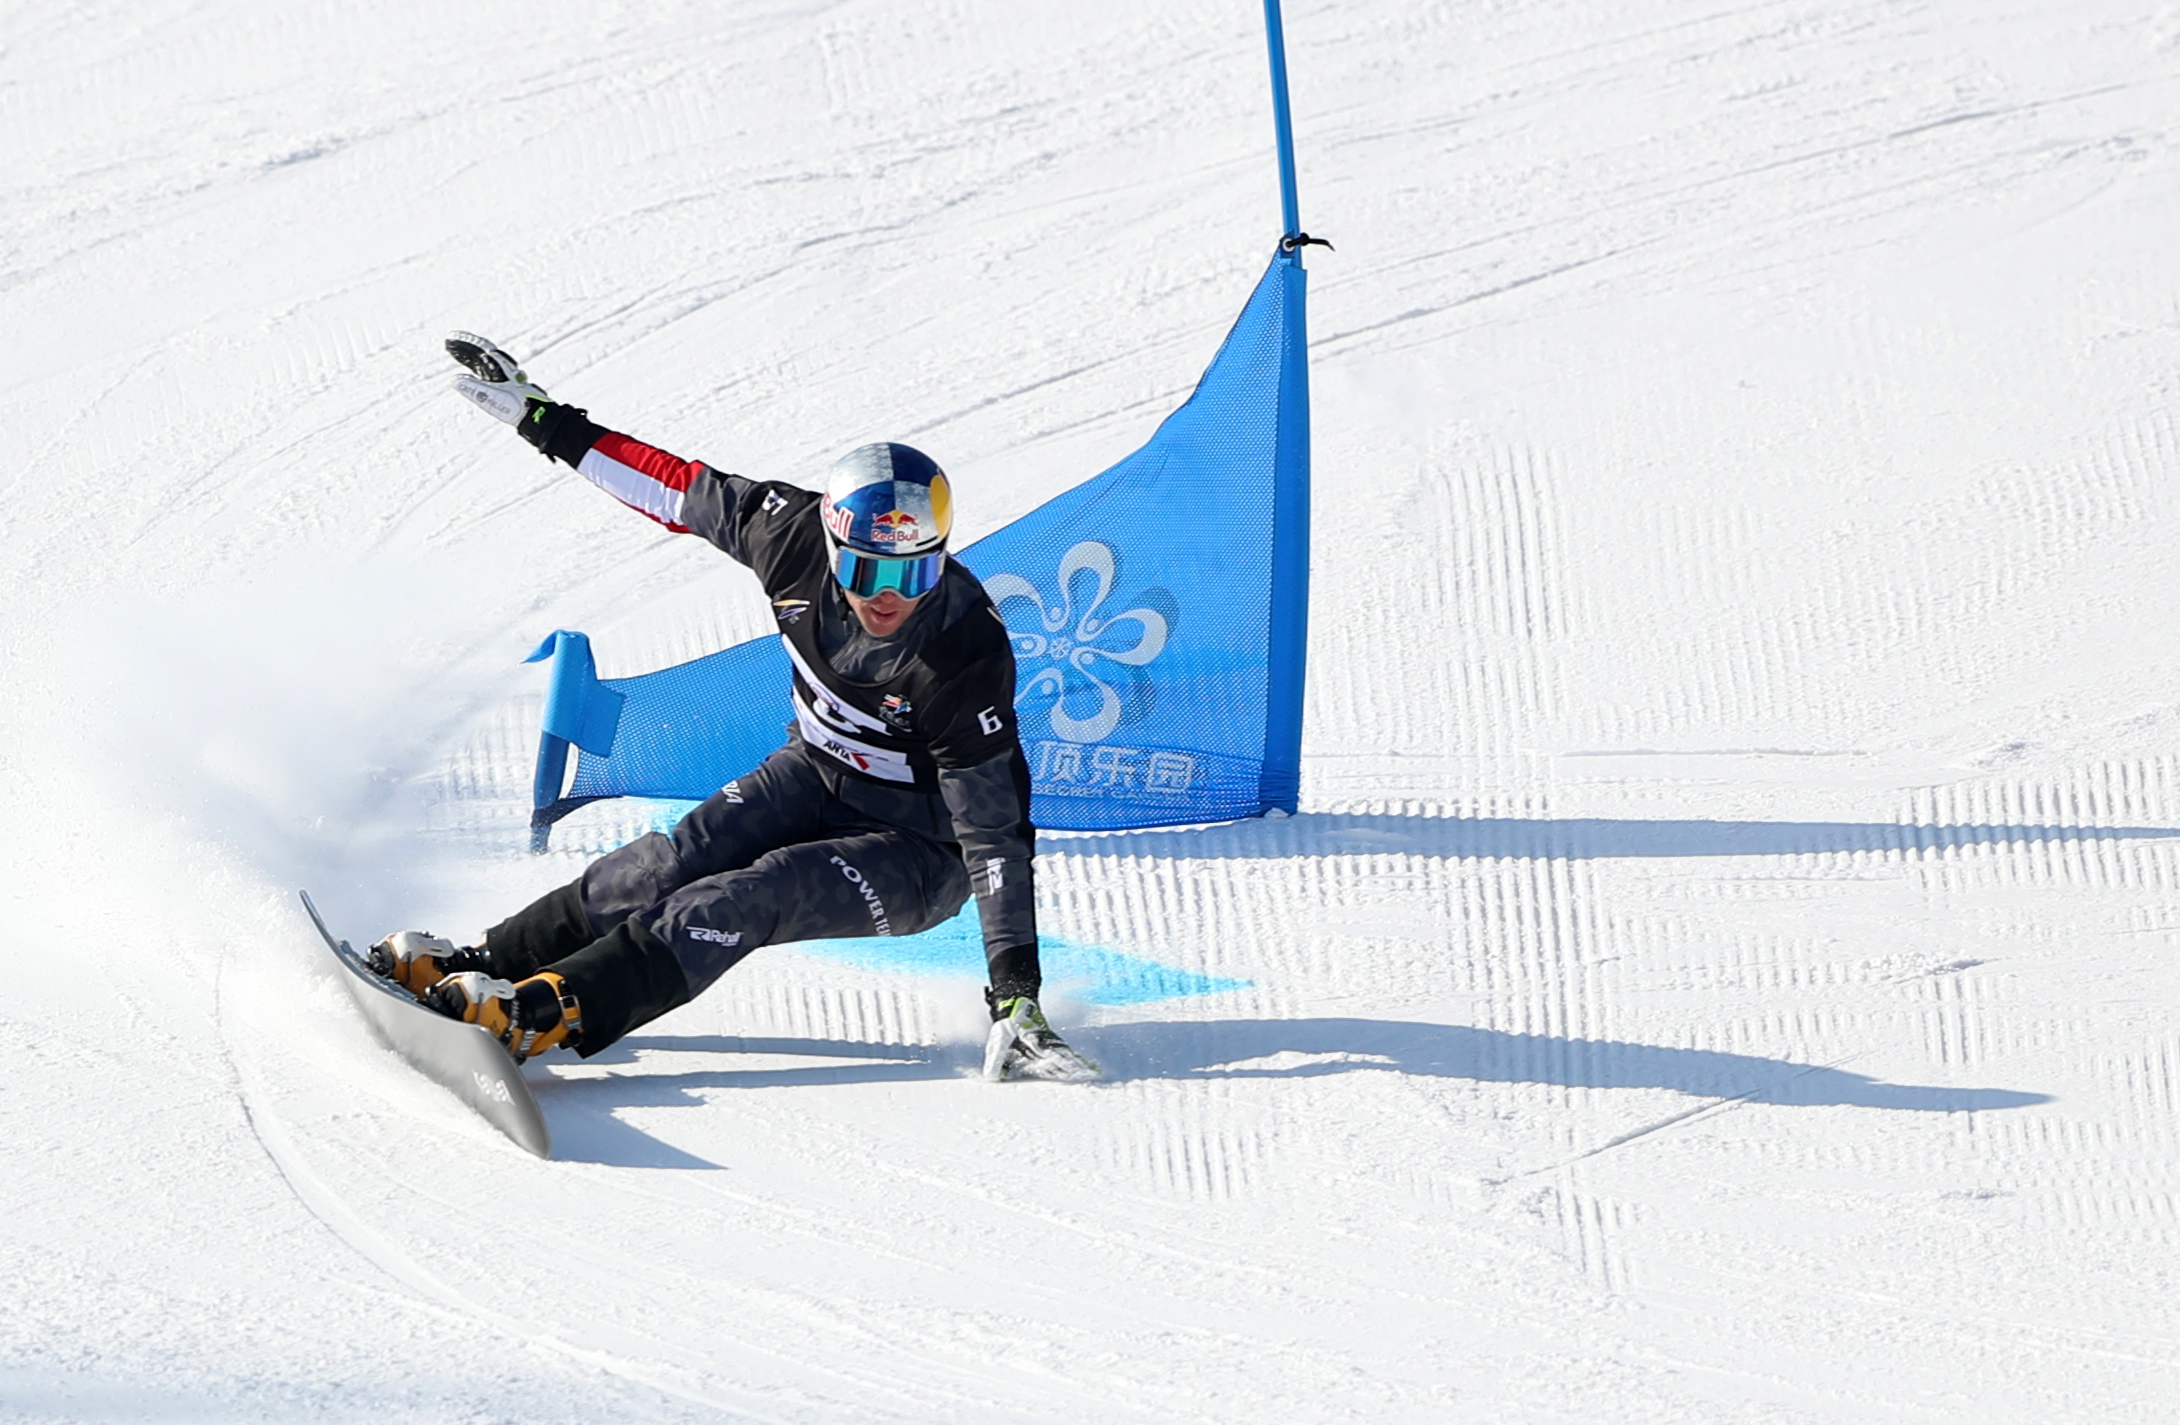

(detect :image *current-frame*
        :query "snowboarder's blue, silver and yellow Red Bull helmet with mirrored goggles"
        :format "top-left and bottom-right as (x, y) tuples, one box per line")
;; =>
(818, 442), (953, 599)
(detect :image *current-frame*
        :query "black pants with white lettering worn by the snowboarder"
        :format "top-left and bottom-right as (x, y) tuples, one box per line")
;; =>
(484, 739), (970, 1057)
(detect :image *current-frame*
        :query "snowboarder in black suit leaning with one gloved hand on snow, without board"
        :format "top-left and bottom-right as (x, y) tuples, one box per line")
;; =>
(368, 331), (1097, 1079)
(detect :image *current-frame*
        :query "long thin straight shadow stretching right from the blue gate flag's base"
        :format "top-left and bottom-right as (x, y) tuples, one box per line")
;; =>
(1044, 813), (2180, 861)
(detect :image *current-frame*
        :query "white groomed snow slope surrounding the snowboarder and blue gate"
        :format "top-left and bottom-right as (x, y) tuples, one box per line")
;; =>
(0, 0), (2180, 1425)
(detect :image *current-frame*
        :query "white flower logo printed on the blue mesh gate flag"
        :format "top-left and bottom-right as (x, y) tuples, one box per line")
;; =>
(983, 540), (1168, 743)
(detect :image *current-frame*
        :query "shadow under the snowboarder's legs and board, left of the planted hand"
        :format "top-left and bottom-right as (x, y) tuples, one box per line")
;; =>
(530, 1035), (961, 1168)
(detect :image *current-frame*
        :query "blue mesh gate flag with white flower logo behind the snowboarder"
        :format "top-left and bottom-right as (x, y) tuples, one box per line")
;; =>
(530, 247), (1310, 850)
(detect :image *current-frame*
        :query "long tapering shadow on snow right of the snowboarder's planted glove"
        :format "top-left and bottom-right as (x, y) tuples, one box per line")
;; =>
(1079, 1020), (2051, 1113)
